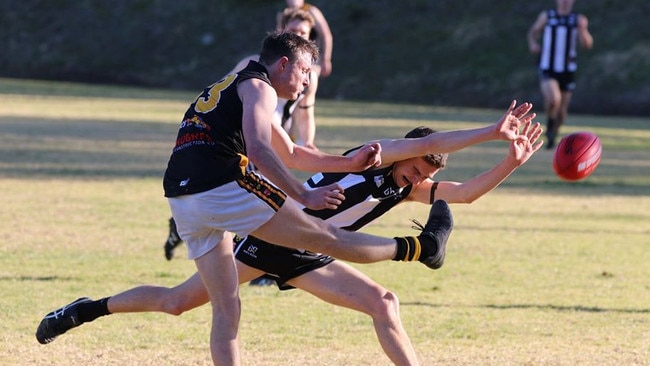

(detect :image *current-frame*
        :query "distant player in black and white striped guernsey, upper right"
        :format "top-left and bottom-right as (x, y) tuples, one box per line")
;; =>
(528, 0), (593, 149)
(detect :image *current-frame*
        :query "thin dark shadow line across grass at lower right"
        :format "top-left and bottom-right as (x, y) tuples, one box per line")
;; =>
(401, 301), (650, 314)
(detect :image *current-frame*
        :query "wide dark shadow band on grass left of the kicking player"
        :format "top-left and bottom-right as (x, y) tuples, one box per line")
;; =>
(0, 117), (176, 179)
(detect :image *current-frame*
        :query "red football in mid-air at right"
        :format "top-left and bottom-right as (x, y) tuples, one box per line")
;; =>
(553, 131), (603, 181)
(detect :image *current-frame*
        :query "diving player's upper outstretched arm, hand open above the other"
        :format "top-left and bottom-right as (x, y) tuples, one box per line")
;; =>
(370, 100), (535, 165)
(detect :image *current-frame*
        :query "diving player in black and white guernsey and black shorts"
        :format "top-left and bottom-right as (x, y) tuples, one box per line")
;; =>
(37, 105), (542, 365)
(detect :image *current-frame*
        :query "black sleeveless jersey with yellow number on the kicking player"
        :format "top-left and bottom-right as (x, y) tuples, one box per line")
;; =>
(163, 61), (271, 197)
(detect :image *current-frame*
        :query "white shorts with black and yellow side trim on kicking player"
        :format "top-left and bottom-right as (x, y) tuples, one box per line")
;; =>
(168, 173), (286, 259)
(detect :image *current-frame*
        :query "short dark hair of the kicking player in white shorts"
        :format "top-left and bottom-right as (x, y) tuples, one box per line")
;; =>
(260, 32), (319, 65)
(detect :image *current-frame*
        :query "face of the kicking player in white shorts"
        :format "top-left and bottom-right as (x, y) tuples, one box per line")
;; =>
(272, 52), (312, 100)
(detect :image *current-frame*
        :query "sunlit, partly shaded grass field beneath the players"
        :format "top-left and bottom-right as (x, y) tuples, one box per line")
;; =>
(0, 79), (650, 366)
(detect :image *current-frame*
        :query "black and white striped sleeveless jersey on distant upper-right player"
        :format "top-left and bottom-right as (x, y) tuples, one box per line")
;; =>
(539, 9), (578, 73)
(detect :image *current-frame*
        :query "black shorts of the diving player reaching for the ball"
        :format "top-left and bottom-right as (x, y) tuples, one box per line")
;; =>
(235, 236), (334, 290)
